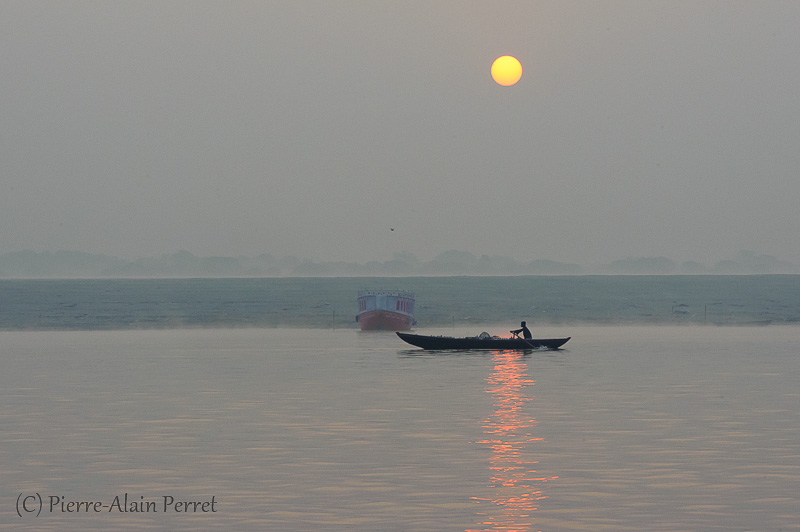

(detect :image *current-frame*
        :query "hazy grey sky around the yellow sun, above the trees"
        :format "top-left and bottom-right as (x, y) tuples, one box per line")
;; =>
(0, 0), (800, 264)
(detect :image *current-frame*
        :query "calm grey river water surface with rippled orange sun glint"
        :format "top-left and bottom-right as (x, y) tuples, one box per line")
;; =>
(0, 326), (800, 532)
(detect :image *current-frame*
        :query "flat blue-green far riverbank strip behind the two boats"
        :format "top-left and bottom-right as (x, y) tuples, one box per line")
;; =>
(0, 275), (800, 334)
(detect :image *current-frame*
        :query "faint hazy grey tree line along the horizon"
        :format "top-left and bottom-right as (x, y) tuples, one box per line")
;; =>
(0, 250), (800, 279)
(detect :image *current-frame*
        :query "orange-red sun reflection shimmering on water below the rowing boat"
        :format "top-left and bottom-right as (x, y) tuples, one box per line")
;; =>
(466, 351), (557, 532)
